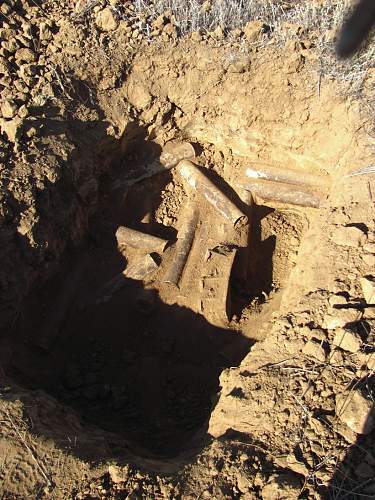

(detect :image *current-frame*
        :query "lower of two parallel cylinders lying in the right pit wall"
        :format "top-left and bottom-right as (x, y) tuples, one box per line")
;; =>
(241, 180), (324, 208)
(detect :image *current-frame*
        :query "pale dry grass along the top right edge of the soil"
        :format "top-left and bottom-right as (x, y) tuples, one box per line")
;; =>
(134, 0), (375, 104)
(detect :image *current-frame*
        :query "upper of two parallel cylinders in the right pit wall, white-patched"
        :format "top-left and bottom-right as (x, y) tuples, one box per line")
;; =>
(245, 165), (327, 187)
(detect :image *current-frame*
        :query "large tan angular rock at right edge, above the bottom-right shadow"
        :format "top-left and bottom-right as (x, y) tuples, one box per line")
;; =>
(336, 391), (375, 434)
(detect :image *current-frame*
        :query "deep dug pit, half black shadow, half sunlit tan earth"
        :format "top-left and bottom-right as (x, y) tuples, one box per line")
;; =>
(5, 147), (307, 457)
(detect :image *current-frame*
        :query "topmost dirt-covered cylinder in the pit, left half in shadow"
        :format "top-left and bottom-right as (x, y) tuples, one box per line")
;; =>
(113, 140), (195, 189)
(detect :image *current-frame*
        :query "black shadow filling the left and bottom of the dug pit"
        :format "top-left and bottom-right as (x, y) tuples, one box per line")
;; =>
(2, 107), (251, 461)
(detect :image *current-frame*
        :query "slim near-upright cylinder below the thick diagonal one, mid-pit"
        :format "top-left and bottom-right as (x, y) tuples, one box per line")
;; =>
(163, 202), (199, 286)
